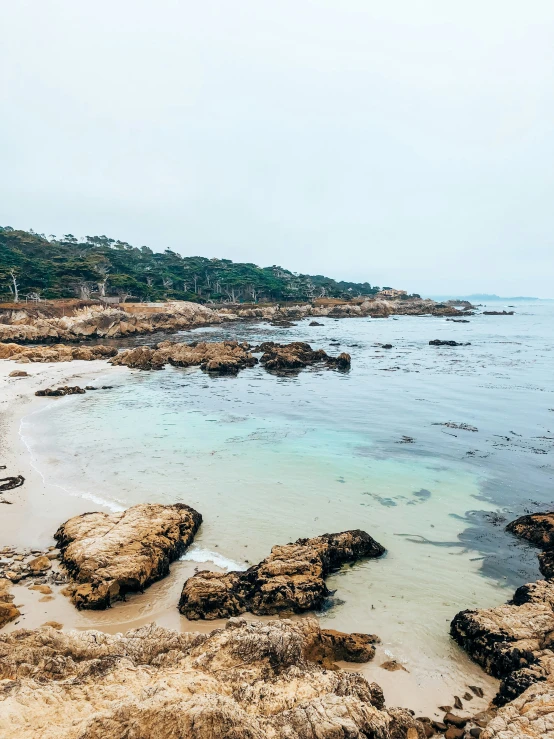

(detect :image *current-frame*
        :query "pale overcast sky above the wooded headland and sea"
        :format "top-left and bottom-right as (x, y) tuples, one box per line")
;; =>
(0, 0), (554, 298)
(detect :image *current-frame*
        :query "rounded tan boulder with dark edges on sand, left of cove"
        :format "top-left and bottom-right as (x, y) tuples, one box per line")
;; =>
(54, 503), (202, 609)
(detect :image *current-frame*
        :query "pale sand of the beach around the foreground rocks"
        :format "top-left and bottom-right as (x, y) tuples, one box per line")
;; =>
(0, 360), (498, 718)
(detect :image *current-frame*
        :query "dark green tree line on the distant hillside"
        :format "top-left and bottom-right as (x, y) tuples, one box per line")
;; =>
(0, 226), (380, 303)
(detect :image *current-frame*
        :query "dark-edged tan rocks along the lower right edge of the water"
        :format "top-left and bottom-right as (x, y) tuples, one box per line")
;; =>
(450, 512), (554, 739)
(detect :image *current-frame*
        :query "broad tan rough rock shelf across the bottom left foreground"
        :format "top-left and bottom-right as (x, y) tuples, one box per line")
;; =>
(0, 619), (425, 739)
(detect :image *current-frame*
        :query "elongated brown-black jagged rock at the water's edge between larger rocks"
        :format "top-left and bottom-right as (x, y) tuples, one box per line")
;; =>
(179, 529), (385, 619)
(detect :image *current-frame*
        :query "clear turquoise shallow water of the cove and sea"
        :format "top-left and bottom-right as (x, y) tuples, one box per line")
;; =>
(24, 302), (554, 700)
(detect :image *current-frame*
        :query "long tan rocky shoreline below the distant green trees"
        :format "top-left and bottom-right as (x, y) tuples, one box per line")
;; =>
(0, 298), (460, 343)
